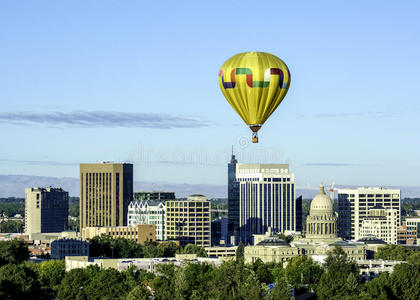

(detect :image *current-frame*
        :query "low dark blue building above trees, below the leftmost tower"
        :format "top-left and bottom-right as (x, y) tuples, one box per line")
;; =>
(51, 239), (89, 259)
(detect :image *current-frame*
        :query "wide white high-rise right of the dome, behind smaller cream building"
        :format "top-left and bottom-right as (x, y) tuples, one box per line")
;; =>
(338, 187), (401, 240)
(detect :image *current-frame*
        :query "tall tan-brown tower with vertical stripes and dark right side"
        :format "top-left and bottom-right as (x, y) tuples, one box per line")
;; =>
(80, 162), (133, 231)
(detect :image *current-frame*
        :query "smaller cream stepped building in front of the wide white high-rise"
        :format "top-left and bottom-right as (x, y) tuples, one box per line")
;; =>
(359, 204), (399, 244)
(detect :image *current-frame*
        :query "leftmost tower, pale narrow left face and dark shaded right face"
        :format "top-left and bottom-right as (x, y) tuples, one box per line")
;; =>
(25, 187), (69, 236)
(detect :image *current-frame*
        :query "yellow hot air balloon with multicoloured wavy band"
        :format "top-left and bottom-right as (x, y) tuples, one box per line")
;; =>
(219, 52), (290, 143)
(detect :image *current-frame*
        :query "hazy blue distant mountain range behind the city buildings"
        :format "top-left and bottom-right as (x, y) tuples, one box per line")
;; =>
(0, 175), (420, 199)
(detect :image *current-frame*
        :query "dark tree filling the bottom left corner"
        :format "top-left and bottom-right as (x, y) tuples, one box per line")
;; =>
(0, 263), (41, 299)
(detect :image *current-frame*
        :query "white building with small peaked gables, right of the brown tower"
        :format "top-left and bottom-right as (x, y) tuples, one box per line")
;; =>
(127, 200), (165, 241)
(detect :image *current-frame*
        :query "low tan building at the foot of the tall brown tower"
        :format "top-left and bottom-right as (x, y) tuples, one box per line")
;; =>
(82, 224), (156, 244)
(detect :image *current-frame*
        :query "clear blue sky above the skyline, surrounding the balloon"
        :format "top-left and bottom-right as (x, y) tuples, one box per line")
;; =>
(0, 0), (420, 186)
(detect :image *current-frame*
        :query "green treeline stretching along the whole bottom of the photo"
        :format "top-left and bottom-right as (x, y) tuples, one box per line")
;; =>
(0, 240), (420, 300)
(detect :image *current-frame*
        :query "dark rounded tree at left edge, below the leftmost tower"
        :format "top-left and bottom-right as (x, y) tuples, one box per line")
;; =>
(0, 239), (29, 266)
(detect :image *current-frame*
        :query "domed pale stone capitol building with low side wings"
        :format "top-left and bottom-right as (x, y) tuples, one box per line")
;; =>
(245, 185), (384, 263)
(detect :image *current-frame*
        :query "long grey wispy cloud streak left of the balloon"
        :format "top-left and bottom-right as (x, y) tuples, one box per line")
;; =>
(0, 111), (211, 129)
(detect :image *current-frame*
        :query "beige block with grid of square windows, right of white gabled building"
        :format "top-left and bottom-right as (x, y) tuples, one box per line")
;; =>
(165, 194), (211, 247)
